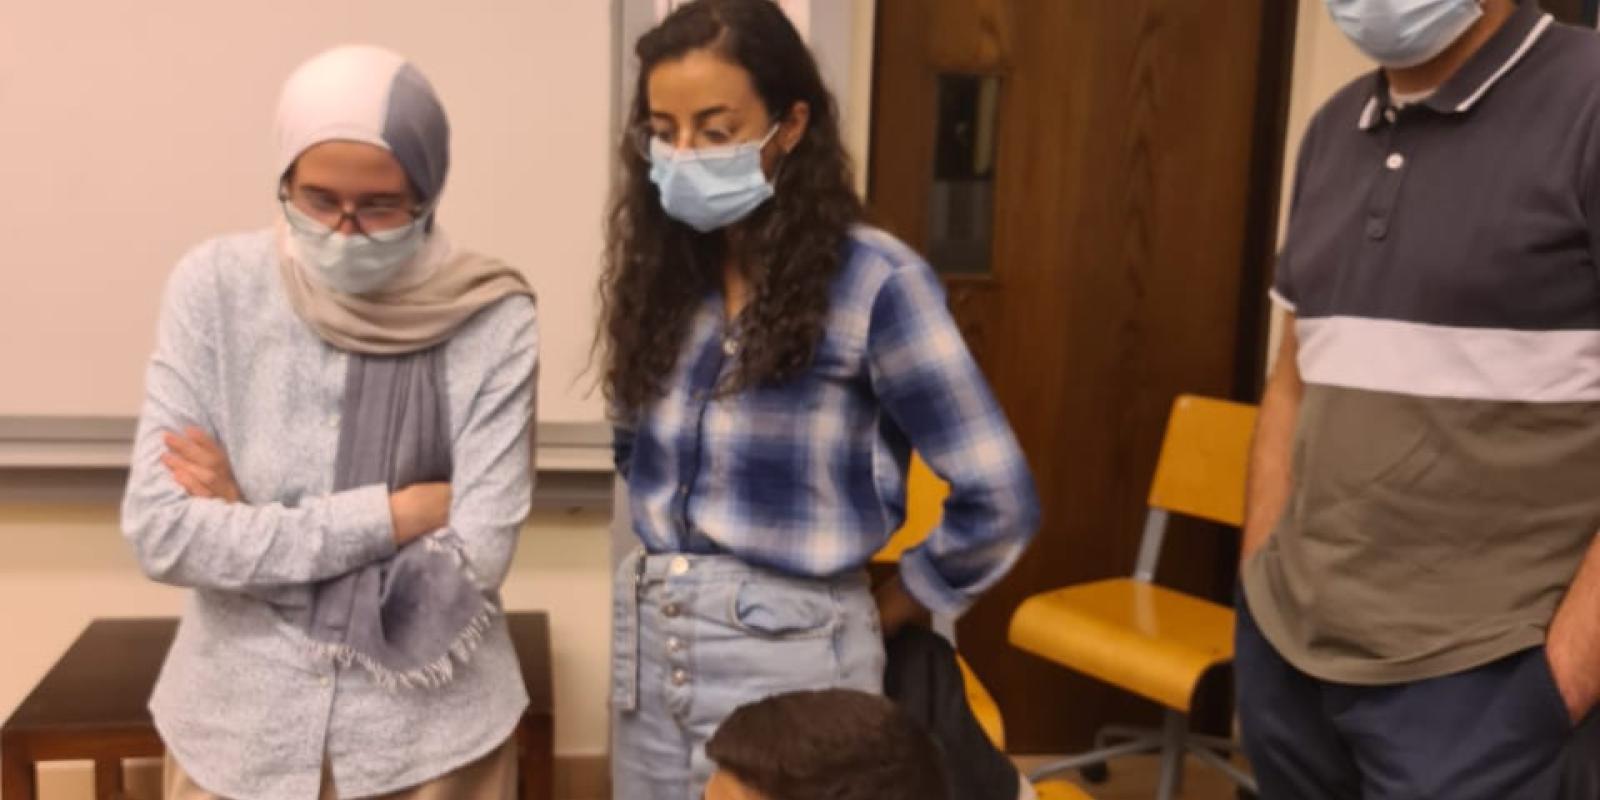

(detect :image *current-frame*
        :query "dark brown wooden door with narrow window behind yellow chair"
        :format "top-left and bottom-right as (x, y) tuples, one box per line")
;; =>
(869, 0), (1296, 752)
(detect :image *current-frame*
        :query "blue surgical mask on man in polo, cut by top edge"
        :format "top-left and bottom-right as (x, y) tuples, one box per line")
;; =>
(1325, 0), (1483, 69)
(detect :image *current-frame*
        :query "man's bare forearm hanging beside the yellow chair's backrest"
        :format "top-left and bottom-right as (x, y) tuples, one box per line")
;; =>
(1240, 314), (1306, 563)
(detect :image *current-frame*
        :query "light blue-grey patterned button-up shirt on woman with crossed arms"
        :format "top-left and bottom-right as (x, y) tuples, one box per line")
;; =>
(123, 232), (538, 800)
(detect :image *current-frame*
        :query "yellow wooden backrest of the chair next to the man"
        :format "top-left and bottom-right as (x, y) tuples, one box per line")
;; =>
(1150, 395), (1256, 526)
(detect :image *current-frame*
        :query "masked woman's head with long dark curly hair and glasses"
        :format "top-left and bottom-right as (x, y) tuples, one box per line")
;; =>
(597, 0), (862, 411)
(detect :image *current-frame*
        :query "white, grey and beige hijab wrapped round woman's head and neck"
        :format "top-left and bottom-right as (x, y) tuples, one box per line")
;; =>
(277, 45), (533, 355)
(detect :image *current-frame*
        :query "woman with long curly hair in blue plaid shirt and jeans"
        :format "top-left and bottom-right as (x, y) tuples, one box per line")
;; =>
(598, 0), (1038, 800)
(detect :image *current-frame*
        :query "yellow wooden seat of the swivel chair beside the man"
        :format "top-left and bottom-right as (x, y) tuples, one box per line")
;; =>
(1010, 578), (1234, 714)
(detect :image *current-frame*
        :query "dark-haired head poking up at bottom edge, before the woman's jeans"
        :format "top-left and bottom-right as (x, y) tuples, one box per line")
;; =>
(706, 690), (949, 800)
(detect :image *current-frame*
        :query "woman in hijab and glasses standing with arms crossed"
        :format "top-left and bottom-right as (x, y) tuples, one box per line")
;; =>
(123, 46), (538, 800)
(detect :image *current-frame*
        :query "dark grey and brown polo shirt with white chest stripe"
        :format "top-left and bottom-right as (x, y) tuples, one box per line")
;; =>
(1243, 0), (1600, 685)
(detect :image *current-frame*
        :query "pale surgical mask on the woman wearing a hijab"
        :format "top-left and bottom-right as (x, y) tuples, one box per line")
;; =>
(283, 203), (427, 294)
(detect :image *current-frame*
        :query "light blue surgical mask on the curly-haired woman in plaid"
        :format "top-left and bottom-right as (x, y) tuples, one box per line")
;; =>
(650, 125), (778, 234)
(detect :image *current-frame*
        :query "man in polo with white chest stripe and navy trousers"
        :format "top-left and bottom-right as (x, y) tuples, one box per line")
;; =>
(1237, 0), (1600, 800)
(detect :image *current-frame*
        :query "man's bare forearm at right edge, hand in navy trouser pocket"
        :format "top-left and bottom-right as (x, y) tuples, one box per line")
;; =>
(1546, 536), (1600, 723)
